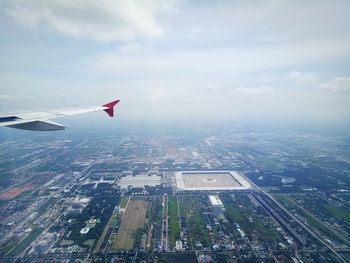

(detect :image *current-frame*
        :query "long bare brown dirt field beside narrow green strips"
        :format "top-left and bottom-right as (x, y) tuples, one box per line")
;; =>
(113, 199), (148, 250)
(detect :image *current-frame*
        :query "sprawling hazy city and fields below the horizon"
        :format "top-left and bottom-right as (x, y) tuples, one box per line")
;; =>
(0, 125), (350, 262)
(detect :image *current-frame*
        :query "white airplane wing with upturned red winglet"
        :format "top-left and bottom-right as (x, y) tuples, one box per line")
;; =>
(0, 100), (120, 131)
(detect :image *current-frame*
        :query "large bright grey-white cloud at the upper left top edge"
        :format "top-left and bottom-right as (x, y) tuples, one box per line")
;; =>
(6, 0), (176, 42)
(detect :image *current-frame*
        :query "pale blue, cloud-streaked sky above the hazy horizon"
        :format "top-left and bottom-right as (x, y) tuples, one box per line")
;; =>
(0, 0), (350, 122)
